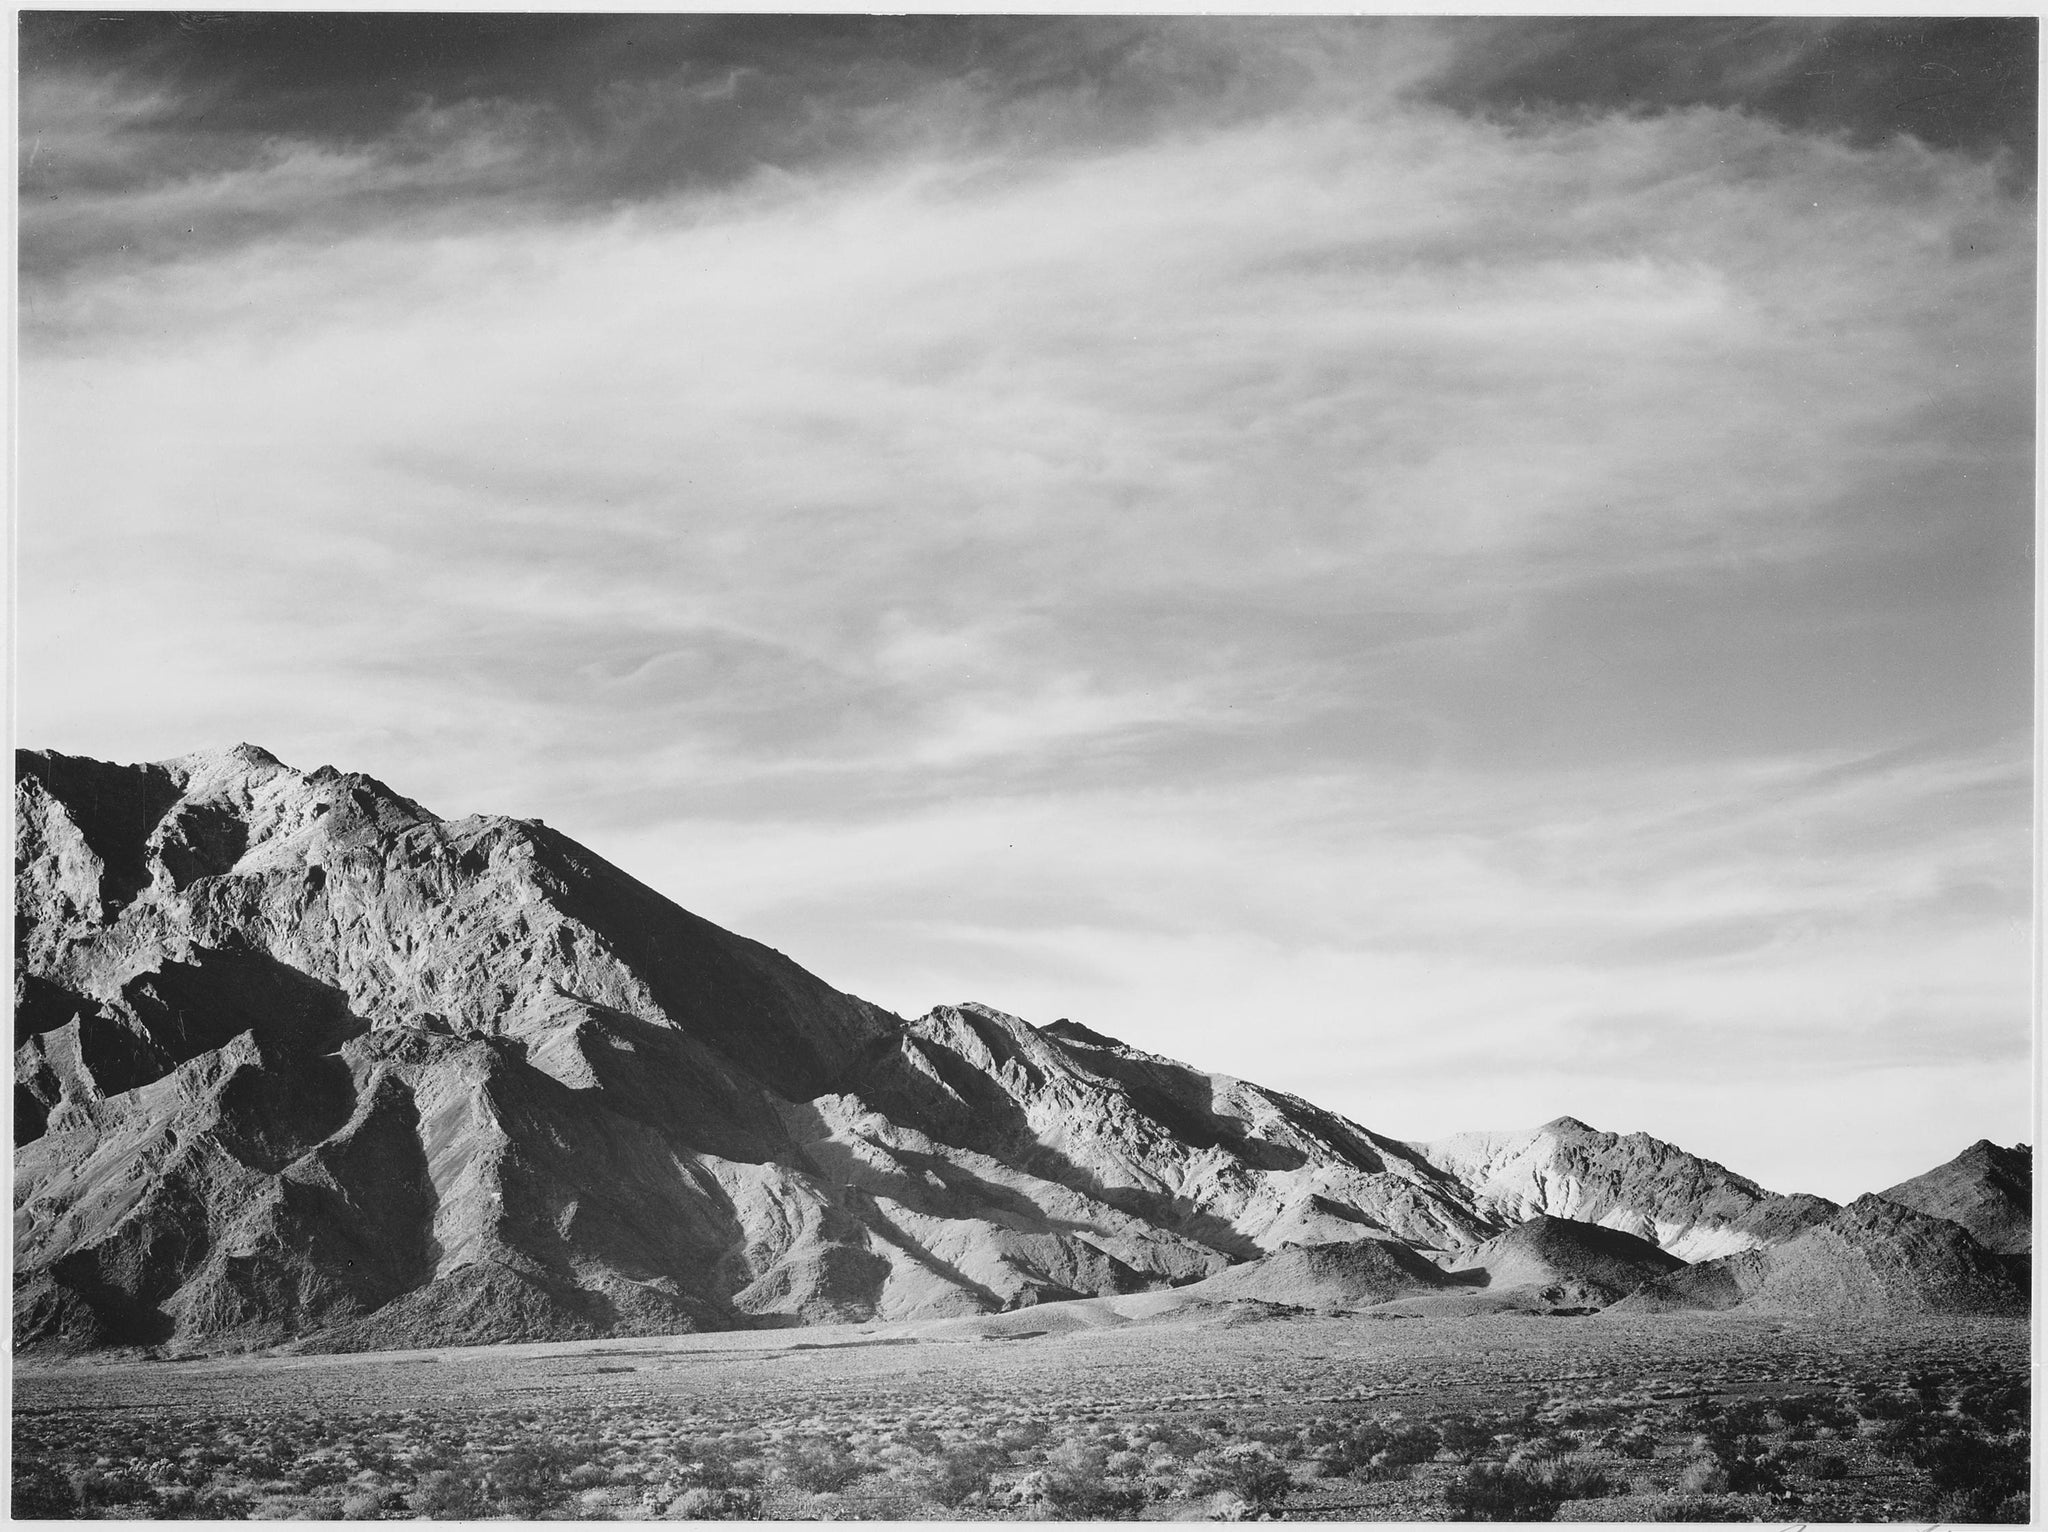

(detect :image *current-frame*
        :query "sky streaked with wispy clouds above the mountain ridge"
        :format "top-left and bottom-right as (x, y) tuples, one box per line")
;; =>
(12, 12), (2036, 1198)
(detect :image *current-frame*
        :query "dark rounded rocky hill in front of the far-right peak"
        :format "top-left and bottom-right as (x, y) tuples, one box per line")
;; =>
(1614, 1196), (2028, 1315)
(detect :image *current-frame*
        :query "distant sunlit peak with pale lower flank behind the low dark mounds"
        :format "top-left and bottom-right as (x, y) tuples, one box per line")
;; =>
(1413, 1116), (1837, 1262)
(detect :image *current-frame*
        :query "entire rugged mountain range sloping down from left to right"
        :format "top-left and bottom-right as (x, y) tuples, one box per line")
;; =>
(14, 746), (2032, 1350)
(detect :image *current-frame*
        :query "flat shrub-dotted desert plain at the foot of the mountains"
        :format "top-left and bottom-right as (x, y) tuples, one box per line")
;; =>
(14, 1305), (2030, 1522)
